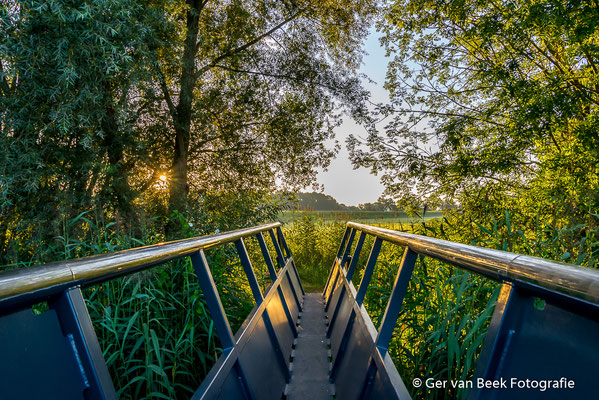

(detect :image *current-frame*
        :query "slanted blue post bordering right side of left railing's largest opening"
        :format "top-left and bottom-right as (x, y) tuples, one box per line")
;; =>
(190, 250), (235, 351)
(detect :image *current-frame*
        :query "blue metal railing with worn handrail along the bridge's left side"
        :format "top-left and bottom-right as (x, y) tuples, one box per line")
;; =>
(0, 223), (304, 399)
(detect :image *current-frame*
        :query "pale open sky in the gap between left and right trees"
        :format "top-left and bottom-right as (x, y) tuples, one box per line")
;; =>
(305, 30), (388, 205)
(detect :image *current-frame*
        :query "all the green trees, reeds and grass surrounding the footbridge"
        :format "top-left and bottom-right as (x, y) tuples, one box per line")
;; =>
(0, 0), (599, 399)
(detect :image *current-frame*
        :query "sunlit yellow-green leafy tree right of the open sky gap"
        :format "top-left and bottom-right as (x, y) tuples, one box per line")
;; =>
(349, 0), (599, 225)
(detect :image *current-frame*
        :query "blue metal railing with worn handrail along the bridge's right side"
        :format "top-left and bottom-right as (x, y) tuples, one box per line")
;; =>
(324, 222), (599, 399)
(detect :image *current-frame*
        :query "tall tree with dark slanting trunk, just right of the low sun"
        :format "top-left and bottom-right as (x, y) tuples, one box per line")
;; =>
(148, 1), (375, 230)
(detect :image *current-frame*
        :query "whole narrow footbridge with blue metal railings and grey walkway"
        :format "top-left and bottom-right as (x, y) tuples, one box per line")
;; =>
(0, 222), (599, 399)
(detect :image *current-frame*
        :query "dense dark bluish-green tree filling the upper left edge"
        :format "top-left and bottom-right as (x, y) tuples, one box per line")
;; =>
(0, 0), (155, 260)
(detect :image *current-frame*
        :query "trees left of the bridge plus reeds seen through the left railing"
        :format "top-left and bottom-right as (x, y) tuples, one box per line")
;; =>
(0, 0), (376, 399)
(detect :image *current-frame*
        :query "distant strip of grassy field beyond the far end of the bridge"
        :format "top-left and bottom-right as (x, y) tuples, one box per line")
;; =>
(279, 210), (443, 225)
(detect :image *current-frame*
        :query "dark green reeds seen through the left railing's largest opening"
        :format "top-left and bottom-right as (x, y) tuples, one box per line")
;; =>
(86, 263), (220, 399)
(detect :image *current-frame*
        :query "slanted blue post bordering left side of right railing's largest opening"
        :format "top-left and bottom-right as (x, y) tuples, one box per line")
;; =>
(376, 247), (418, 355)
